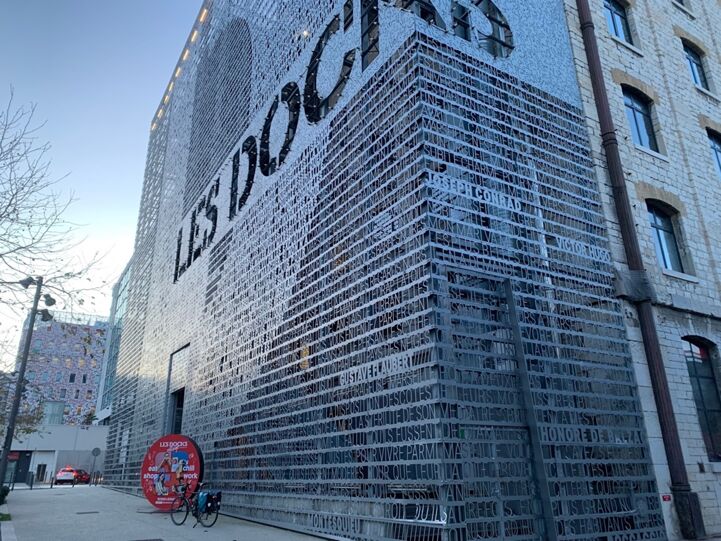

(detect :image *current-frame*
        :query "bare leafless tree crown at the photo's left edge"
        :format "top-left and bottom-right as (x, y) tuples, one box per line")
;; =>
(0, 89), (102, 313)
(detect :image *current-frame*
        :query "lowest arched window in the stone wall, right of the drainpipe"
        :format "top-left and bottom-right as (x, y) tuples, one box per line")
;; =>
(683, 336), (721, 462)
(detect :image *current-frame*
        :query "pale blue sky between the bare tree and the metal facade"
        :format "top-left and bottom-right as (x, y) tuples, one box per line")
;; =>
(0, 0), (201, 364)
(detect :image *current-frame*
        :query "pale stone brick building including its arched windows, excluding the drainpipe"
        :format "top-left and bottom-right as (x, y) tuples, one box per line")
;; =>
(566, 0), (721, 539)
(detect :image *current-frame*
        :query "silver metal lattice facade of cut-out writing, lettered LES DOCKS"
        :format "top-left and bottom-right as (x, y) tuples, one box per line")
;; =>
(107, 0), (665, 541)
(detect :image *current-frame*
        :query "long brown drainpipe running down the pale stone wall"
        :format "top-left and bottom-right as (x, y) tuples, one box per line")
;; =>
(576, 0), (706, 539)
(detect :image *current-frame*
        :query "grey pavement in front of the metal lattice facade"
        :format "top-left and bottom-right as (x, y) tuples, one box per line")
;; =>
(0, 485), (319, 541)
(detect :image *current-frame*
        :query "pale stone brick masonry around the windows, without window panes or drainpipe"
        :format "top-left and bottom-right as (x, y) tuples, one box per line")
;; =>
(566, 0), (721, 538)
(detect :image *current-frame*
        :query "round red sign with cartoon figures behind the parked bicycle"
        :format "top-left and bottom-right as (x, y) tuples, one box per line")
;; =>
(140, 434), (203, 511)
